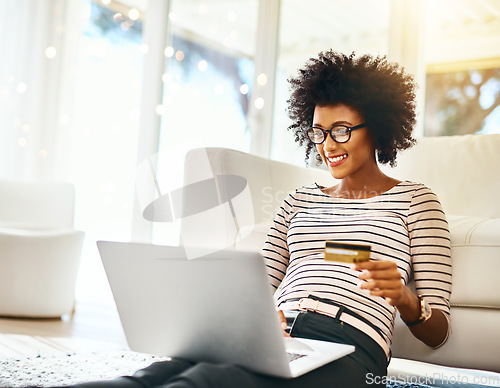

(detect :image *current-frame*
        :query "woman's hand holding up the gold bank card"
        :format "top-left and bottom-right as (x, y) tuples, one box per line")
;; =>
(352, 260), (405, 306)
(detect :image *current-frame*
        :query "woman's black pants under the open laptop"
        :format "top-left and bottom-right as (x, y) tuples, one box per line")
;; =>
(52, 312), (387, 388)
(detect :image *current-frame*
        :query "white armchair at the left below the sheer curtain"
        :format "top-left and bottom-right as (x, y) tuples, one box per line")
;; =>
(0, 180), (84, 318)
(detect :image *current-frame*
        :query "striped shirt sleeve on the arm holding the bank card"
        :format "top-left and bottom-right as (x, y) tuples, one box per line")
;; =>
(408, 186), (451, 344)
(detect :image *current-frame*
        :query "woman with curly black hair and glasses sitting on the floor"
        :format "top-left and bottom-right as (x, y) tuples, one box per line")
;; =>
(64, 51), (451, 388)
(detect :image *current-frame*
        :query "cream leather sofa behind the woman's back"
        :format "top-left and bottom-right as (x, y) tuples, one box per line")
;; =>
(181, 135), (500, 386)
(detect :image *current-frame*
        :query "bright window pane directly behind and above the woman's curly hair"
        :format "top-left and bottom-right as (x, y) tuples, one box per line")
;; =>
(271, 0), (389, 166)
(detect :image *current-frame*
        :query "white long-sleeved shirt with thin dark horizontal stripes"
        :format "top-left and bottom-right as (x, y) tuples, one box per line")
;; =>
(262, 181), (451, 354)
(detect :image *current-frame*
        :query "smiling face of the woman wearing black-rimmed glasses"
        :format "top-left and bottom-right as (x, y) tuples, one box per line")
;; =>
(313, 104), (377, 179)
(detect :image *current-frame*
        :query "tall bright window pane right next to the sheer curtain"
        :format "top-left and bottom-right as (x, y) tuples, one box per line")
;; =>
(68, 1), (143, 300)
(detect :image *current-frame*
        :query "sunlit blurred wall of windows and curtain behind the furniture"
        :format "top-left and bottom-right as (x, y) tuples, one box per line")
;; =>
(0, 0), (500, 299)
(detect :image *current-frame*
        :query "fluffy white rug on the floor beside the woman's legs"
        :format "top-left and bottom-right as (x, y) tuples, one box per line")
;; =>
(0, 334), (165, 388)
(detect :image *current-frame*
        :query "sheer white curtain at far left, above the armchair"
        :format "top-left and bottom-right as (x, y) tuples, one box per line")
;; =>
(0, 0), (82, 180)
